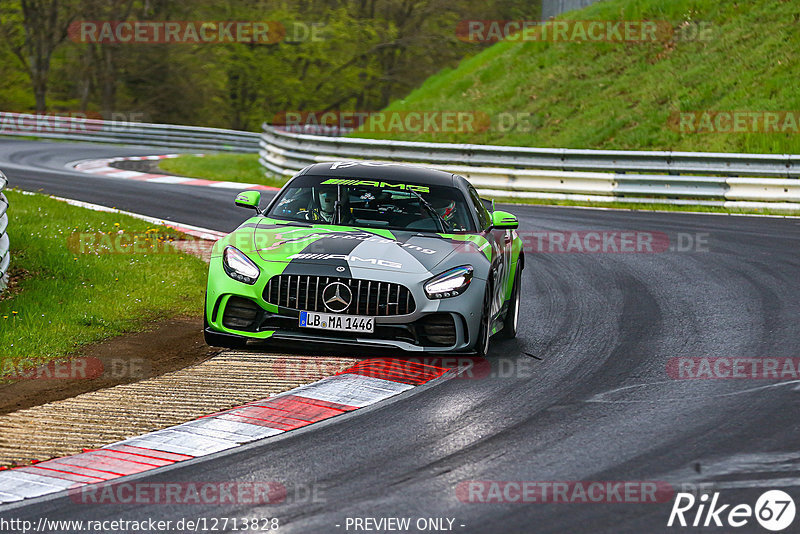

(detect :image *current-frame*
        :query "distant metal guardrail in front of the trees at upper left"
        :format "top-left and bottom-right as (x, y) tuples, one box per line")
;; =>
(0, 112), (259, 153)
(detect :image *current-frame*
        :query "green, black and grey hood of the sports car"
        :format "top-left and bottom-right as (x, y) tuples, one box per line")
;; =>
(247, 220), (482, 274)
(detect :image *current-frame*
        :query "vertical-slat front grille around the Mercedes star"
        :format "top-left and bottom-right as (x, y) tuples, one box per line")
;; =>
(264, 275), (416, 317)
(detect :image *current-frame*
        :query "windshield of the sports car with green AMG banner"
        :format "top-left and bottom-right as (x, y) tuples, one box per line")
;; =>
(267, 176), (475, 233)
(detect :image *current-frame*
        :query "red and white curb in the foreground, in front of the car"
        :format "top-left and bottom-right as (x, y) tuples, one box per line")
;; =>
(0, 359), (452, 504)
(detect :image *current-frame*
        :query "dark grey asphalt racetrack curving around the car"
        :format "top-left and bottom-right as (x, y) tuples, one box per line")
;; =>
(0, 140), (800, 533)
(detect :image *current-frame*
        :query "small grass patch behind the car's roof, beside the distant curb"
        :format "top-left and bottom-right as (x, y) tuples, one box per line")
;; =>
(158, 154), (286, 187)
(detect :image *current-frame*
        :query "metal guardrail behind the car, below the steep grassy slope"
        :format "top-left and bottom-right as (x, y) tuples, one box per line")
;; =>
(259, 123), (800, 210)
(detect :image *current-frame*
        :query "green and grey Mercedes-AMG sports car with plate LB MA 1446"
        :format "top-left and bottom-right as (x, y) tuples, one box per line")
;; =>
(205, 161), (524, 355)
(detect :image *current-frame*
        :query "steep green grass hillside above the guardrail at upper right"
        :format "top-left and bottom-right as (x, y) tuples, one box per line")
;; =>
(354, 0), (800, 153)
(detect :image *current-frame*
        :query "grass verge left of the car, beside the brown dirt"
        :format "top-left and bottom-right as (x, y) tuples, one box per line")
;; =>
(0, 191), (207, 375)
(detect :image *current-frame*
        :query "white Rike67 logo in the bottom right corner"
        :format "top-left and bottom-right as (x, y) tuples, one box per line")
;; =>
(667, 490), (796, 532)
